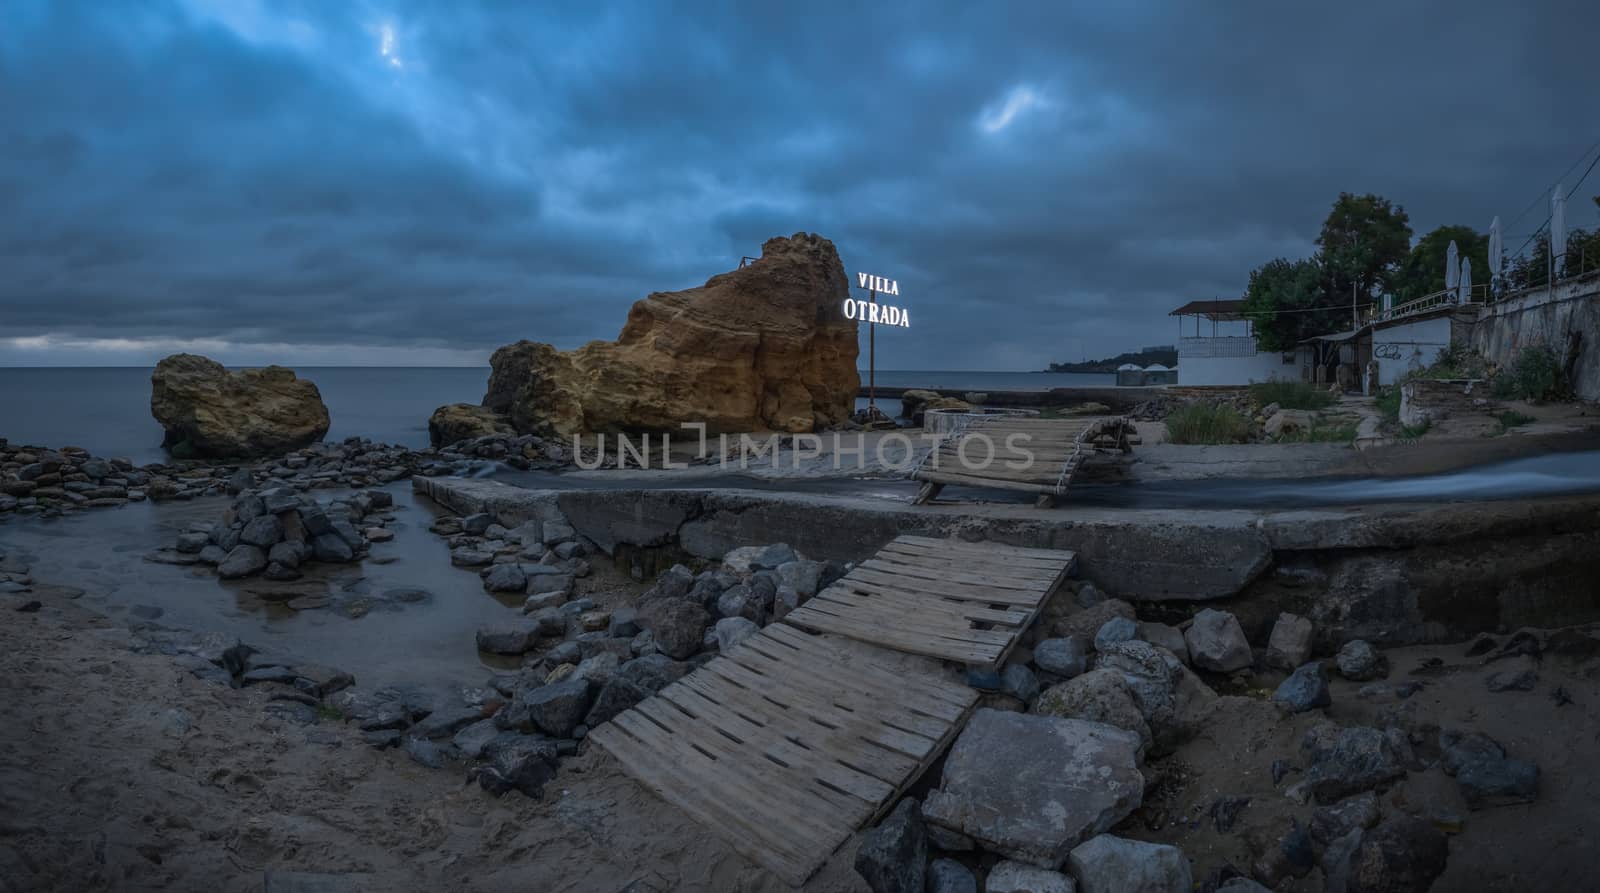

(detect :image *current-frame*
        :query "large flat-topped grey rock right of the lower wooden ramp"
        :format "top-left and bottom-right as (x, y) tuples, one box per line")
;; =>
(923, 709), (1144, 867)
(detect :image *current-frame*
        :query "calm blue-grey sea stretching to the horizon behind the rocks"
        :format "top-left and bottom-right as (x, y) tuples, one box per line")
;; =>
(0, 366), (1115, 464)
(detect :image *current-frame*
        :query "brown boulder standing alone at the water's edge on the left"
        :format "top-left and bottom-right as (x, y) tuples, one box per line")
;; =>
(150, 354), (330, 458)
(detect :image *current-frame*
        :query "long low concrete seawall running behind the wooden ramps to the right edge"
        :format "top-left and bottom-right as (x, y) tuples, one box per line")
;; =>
(413, 479), (1600, 642)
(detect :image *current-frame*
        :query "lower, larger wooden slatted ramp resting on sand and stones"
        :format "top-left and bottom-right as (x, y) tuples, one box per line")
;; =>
(589, 624), (978, 887)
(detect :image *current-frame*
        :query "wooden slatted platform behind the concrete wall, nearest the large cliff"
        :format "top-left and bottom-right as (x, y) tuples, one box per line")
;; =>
(910, 416), (1133, 506)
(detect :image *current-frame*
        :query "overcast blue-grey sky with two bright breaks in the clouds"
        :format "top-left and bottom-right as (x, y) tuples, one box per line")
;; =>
(0, 0), (1600, 370)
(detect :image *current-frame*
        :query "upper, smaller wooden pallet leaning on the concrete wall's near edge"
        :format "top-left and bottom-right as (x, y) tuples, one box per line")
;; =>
(784, 536), (1077, 669)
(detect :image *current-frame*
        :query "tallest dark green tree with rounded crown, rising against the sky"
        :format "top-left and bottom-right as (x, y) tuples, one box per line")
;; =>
(1317, 192), (1411, 312)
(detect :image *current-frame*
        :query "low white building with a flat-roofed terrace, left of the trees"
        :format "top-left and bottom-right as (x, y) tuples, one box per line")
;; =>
(1168, 301), (1301, 386)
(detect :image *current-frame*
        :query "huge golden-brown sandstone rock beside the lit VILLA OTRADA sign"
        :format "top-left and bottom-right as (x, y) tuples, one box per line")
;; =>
(483, 232), (861, 434)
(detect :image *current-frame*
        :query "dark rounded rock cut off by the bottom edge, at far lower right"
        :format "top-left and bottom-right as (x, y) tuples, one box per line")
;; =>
(1323, 815), (1450, 893)
